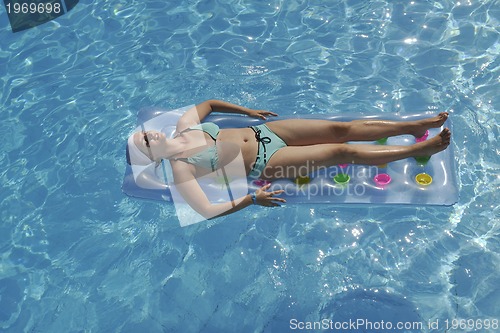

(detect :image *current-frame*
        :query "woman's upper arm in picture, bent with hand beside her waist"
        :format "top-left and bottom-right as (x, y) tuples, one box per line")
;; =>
(177, 99), (277, 131)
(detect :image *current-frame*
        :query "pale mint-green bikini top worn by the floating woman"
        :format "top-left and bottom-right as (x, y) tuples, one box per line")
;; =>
(175, 123), (219, 171)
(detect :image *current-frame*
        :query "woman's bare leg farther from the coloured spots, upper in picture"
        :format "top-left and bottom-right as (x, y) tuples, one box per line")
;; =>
(266, 112), (448, 146)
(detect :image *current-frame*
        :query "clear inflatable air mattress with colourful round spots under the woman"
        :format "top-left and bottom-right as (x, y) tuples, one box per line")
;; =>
(122, 106), (458, 209)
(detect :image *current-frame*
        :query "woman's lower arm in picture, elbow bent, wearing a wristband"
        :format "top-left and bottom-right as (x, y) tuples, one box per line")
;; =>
(173, 162), (286, 219)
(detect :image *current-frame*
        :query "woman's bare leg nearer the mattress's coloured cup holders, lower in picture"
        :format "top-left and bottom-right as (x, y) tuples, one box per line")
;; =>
(262, 128), (451, 179)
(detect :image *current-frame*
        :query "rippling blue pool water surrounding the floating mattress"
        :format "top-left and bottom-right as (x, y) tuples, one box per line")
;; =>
(0, 0), (500, 332)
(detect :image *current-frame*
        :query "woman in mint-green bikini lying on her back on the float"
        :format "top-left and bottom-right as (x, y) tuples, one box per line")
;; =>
(129, 100), (451, 218)
